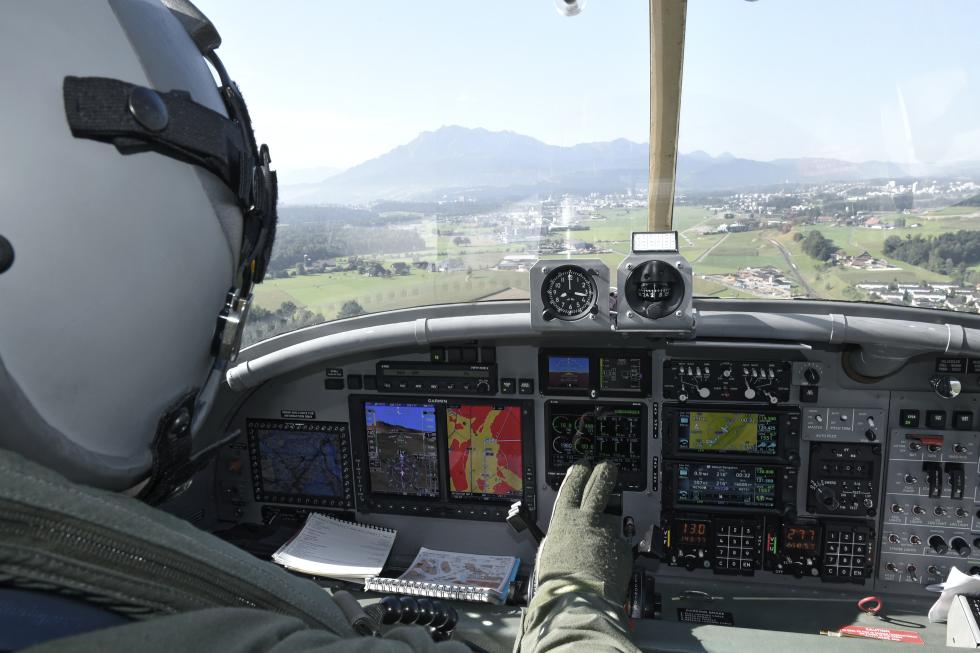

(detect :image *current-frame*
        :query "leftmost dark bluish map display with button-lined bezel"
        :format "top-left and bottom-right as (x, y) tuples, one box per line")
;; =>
(246, 419), (354, 509)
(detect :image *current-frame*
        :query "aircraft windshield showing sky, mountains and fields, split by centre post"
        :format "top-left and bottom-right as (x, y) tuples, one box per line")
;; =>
(198, 0), (980, 344)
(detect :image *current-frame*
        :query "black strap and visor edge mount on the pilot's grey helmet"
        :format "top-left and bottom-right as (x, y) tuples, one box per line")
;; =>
(62, 50), (278, 367)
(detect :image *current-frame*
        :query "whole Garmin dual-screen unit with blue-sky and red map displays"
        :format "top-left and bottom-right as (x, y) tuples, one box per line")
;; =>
(350, 397), (535, 519)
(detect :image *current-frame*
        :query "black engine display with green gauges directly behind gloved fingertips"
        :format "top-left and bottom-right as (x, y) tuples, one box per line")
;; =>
(545, 401), (646, 490)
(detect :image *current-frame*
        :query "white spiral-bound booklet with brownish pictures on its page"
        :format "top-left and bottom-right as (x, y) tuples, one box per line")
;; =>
(364, 547), (521, 605)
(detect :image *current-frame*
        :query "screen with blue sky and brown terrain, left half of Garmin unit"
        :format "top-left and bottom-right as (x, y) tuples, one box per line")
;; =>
(364, 402), (439, 497)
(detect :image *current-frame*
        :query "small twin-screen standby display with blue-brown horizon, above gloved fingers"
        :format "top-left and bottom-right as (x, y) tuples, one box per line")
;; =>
(538, 349), (652, 397)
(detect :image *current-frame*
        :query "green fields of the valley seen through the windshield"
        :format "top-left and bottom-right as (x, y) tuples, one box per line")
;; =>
(255, 206), (980, 320)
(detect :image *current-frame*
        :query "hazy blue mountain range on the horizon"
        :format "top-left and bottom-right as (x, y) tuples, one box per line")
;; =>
(280, 126), (980, 204)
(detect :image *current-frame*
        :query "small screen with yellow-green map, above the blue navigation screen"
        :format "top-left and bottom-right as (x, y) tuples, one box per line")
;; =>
(677, 410), (779, 456)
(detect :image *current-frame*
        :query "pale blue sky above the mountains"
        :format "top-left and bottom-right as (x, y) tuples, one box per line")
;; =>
(195, 0), (980, 177)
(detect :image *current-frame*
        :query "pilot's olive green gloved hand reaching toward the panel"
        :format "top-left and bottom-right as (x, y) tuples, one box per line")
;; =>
(535, 461), (633, 605)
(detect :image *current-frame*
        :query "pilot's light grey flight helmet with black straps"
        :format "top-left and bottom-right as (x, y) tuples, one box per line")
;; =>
(0, 0), (276, 501)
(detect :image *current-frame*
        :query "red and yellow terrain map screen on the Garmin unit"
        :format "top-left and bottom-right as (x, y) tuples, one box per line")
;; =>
(446, 404), (524, 500)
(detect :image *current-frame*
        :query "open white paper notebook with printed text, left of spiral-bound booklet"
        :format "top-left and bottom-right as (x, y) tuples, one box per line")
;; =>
(272, 512), (396, 582)
